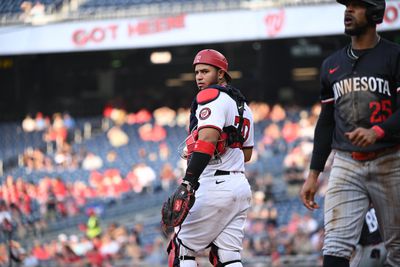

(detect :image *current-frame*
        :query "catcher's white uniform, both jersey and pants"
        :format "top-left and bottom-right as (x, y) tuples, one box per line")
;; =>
(175, 91), (254, 255)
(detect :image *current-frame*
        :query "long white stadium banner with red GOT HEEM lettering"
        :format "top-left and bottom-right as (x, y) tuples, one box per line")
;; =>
(0, 1), (400, 55)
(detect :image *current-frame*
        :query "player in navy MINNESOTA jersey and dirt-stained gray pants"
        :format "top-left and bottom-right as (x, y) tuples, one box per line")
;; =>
(301, 0), (400, 267)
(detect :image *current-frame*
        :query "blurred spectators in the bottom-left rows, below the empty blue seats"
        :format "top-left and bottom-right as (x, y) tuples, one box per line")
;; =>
(0, 220), (166, 267)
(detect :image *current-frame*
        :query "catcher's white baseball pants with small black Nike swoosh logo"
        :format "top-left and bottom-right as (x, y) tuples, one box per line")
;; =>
(175, 173), (251, 252)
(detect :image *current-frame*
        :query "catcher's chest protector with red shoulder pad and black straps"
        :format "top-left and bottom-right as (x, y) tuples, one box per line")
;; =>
(179, 85), (246, 158)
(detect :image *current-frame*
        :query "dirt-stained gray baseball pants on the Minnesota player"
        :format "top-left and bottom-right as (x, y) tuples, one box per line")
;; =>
(323, 151), (400, 267)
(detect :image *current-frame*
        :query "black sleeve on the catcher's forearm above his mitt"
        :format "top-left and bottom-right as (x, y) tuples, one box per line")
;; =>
(183, 151), (211, 190)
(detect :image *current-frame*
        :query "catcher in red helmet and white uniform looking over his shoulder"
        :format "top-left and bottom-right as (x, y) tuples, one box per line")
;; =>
(164, 49), (254, 267)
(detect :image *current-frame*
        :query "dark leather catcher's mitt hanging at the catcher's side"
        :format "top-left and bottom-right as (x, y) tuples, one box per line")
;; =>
(161, 181), (195, 230)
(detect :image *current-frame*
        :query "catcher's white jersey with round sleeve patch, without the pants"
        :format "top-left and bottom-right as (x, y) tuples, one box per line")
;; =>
(196, 92), (254, 176)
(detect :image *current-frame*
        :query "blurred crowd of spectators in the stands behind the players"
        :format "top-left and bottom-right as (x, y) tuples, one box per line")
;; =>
(0, 103), (329, 266)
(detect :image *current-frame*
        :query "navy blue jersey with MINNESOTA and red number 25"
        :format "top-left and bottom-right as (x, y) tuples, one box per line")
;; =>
(321, 39), (400, 152)
